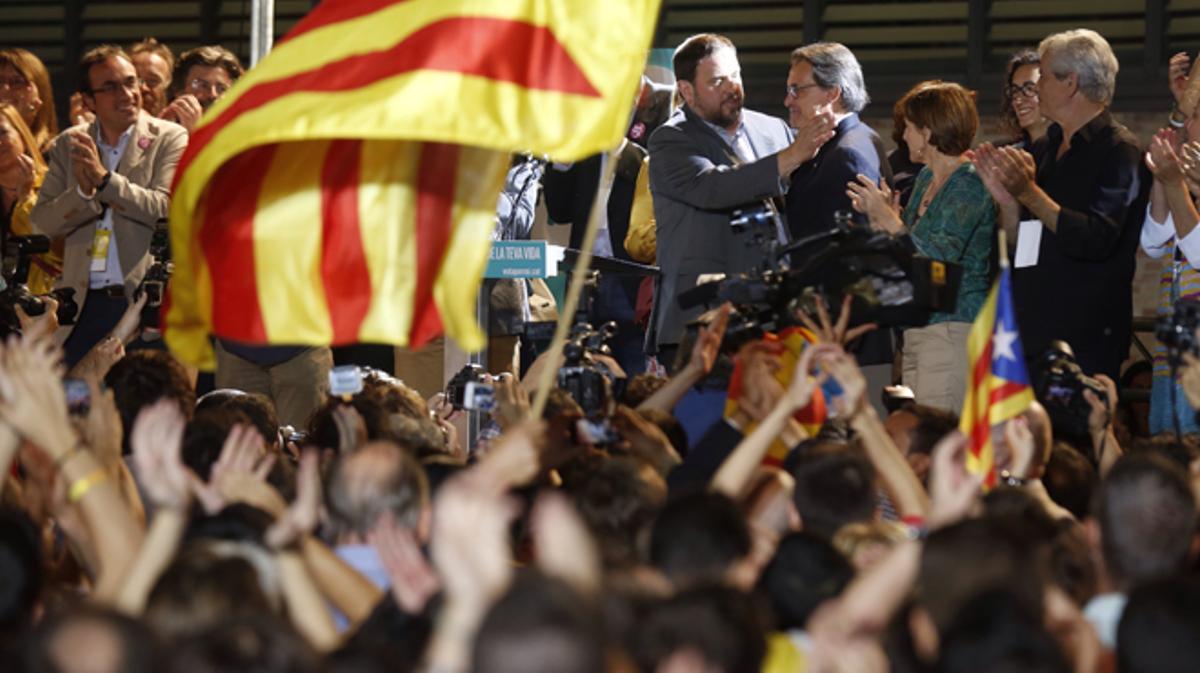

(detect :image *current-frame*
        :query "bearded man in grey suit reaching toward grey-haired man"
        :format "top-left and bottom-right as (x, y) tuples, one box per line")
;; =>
(647, 34), (834, 367)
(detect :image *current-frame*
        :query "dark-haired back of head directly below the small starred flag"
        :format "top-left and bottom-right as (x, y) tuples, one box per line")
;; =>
(917, 518), (1045, 633)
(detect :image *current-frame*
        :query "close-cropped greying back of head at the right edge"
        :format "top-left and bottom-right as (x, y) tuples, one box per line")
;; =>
(1096, 452), (1196, 590)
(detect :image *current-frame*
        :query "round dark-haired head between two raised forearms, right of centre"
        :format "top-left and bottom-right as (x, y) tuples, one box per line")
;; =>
(792, 449), (877, 540)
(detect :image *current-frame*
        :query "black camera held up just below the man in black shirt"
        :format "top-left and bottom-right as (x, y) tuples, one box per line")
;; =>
(1033, 341), (1109, 437)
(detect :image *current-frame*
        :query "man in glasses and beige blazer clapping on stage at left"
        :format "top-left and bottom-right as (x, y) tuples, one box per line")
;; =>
(31, 46), (187, 366)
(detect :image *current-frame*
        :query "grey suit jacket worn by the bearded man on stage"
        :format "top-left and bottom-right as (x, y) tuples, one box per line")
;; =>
(647, 106), (791, 348)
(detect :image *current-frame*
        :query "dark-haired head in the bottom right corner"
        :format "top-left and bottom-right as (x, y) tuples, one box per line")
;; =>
(1117, 576), (1200, 673)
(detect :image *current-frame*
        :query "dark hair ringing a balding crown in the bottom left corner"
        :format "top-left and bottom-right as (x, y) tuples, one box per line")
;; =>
(17, 603), (162, 673)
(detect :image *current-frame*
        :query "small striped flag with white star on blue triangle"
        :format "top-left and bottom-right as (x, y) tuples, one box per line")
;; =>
(959, 260), (1033, 488)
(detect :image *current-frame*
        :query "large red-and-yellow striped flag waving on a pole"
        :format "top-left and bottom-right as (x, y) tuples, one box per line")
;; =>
(163, 0), (660, 366)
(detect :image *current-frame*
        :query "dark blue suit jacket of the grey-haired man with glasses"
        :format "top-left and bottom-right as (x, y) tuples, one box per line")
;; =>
(787, 114), (892, 241)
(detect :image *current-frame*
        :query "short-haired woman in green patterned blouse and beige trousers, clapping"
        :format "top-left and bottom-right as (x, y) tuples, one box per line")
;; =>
(847, 80), (996, 413)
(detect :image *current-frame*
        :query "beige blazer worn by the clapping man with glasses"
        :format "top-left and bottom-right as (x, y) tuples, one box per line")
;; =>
(30, 112), (187, 339)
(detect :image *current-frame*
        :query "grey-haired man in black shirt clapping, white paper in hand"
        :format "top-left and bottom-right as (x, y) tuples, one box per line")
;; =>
(974, 30), (1150, 378)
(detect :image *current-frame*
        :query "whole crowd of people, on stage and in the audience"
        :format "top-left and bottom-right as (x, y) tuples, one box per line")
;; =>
(0, 23), (1200, 673)
